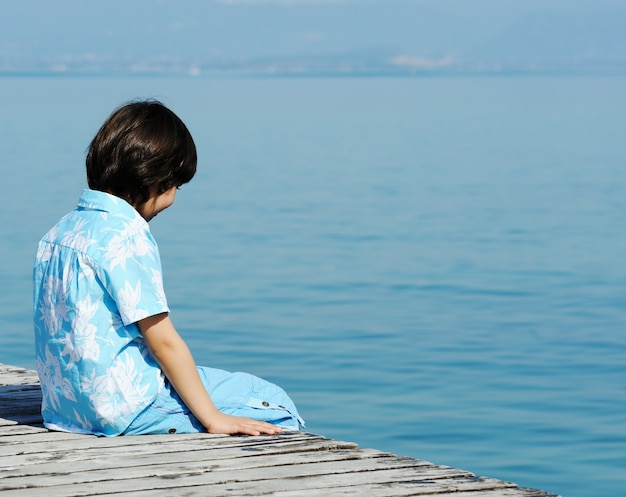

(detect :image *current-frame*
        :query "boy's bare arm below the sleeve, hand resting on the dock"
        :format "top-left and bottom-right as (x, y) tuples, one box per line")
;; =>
(137, 313), (281, 435)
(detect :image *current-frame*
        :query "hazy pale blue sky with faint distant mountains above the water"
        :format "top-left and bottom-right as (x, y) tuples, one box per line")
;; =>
(0, 0), (626, 72)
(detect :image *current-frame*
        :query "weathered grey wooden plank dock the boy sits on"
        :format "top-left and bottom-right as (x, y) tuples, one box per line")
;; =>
(0, 364), (556, 497)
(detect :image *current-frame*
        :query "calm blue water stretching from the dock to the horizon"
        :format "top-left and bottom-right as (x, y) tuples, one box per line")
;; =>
(0, 77), (626, 497)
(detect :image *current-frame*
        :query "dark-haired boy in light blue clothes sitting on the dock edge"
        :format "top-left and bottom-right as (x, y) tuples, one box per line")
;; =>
(33, 101), (303, 436)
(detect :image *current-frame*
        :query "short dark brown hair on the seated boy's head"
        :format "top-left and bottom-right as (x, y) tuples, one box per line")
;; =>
(86, 100), (197, 207)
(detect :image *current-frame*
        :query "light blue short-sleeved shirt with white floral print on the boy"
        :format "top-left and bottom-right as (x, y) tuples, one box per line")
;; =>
(33, 190), (168, 435)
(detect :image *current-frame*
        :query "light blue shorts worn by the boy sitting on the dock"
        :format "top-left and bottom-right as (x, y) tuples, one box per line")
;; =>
(123, 367), (304, 435)
